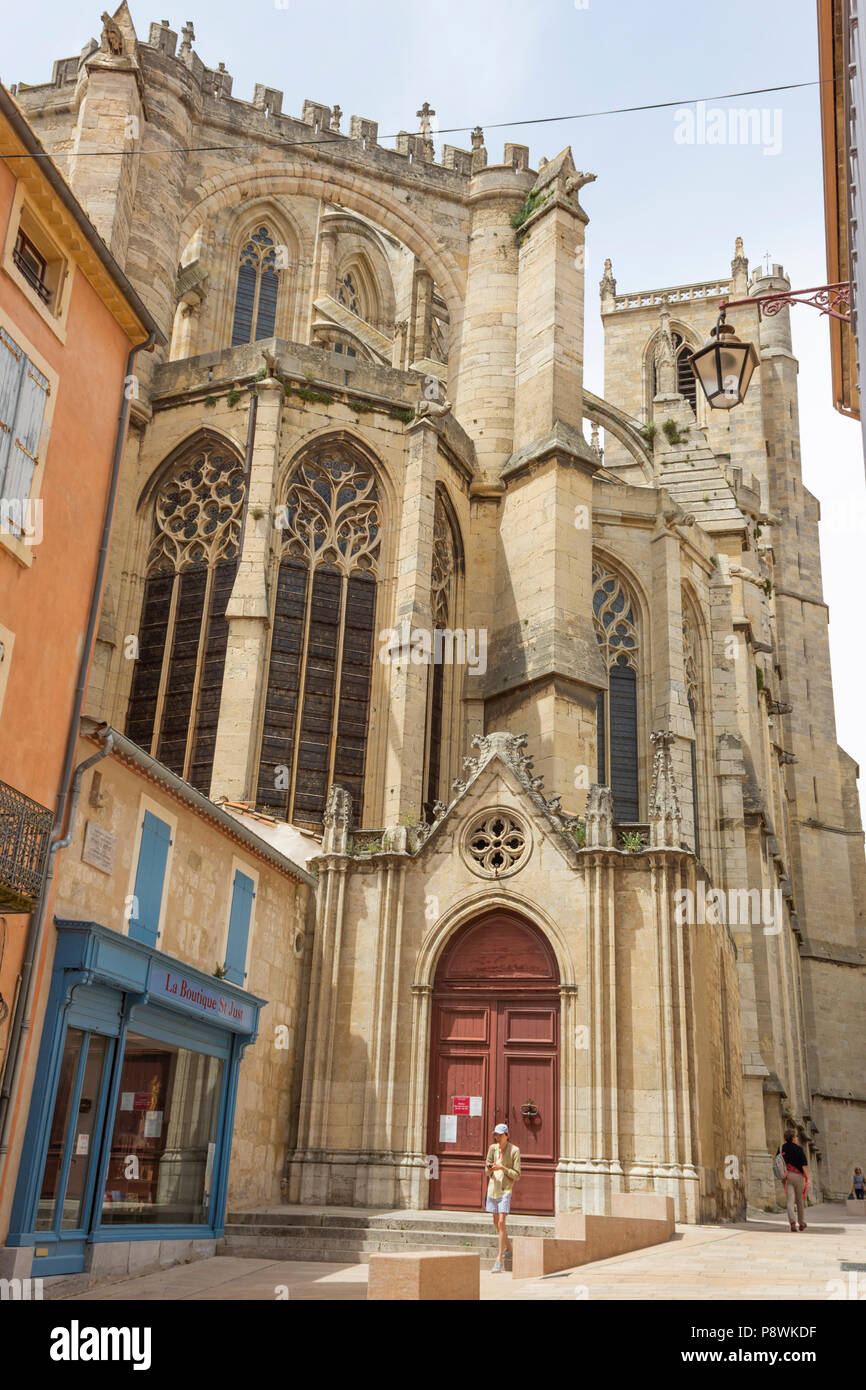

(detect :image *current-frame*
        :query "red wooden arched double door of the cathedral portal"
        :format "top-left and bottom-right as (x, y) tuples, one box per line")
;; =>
(427, 909), (559, 1215)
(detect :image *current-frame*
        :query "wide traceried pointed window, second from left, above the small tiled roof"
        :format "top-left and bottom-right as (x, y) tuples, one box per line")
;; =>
(257, 442), (381, 826)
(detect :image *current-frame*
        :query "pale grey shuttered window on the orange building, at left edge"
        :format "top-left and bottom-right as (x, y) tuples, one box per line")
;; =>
(0, 328), (50, 511)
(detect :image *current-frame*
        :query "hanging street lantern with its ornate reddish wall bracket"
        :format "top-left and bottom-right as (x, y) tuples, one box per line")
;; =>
(689, 281), (851, 410)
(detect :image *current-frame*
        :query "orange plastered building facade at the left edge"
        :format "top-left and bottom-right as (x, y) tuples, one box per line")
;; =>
(0, 88), (158, 1238)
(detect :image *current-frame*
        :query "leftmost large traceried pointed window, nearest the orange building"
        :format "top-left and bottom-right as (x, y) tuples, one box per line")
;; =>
(126, 438), (245, 795)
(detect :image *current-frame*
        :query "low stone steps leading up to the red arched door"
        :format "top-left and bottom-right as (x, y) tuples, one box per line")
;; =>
(217, 1207), (553, 1269)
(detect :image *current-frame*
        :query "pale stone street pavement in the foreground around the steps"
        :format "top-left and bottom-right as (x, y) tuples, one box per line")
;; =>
(55, 1204), (866, 1302)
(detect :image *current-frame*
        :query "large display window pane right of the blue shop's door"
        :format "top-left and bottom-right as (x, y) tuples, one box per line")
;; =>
(101, 1033), (224, 1226)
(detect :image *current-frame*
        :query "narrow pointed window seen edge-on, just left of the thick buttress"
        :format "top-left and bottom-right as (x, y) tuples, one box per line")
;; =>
(423, 487), (463, 819)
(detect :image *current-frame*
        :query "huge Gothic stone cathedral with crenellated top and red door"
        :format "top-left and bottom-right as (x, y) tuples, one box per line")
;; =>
(17, 3), (866, 1220)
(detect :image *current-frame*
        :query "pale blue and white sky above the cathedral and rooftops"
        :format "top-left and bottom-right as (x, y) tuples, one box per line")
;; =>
(6, 0), (866, 817)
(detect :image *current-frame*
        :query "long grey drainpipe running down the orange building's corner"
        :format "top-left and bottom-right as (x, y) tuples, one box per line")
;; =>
(0, 329), (158, 1187)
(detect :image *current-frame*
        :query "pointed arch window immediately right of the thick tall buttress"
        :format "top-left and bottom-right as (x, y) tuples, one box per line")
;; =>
(592, 563), (639, 821)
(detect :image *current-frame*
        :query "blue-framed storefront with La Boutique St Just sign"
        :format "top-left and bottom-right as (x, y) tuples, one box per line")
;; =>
(7, 922), (267, 1276)
